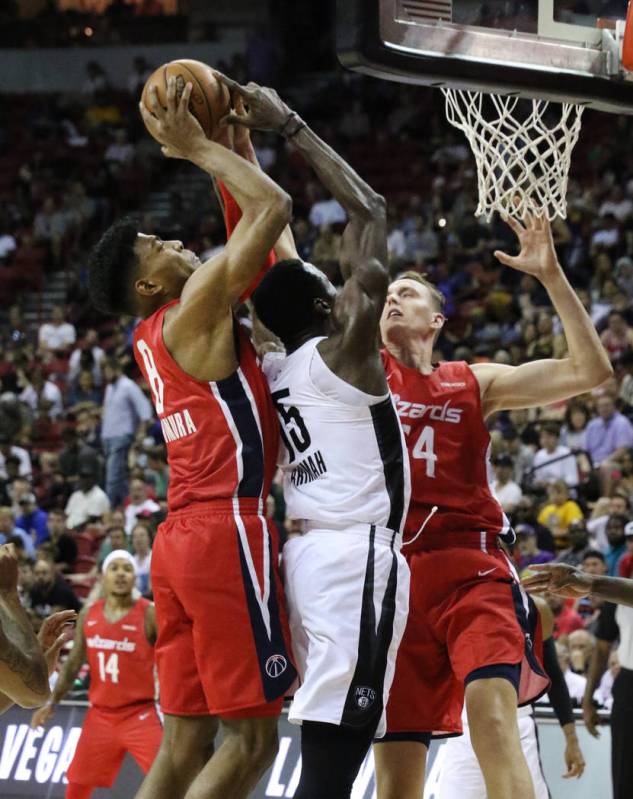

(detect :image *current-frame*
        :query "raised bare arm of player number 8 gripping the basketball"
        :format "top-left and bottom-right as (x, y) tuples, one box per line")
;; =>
(140, 79), (292, 322)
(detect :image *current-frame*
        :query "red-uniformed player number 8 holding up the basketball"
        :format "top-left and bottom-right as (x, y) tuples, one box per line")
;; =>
(86, 80), (296, 799)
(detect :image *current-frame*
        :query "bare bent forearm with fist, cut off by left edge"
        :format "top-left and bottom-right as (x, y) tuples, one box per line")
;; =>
(0, 544), (50, 711)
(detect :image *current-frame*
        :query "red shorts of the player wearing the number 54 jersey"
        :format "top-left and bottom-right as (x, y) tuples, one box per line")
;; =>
(387, 547), (549, 737)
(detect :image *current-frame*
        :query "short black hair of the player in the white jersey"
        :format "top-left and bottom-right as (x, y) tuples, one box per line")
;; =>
(253, 258), (331, 343)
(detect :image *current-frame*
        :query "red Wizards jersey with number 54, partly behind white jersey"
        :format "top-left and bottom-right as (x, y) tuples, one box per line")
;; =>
(382, 350), (507, 554)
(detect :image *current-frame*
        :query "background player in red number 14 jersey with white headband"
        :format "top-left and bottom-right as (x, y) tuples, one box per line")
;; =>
(31, 549), (163, 799)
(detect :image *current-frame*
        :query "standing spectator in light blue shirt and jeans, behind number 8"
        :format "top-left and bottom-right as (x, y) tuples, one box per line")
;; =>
(101, 358), (152, 505)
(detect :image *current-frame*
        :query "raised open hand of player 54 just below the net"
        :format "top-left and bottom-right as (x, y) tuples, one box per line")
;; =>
(494, 213), (560, 282)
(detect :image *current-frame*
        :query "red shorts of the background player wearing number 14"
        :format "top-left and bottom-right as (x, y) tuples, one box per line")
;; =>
(66, 704), (163, 788)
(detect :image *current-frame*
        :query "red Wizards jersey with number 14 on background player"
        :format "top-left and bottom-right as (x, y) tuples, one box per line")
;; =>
(84, 598), (155, 710)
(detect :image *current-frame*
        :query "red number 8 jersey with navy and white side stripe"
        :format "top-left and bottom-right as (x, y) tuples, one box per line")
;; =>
(134, 300), (279, 511)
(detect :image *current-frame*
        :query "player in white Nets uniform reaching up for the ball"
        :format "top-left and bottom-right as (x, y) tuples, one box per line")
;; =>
(229, 76), (410, 799)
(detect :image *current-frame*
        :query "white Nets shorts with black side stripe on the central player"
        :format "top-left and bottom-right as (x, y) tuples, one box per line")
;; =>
(283, 525), (409, 737)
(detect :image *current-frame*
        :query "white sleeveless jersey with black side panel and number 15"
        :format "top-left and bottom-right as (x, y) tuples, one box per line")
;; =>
(263, 338), (410, 532)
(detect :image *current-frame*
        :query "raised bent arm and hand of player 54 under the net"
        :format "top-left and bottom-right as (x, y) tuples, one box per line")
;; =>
(473, 216), (613, 416)
